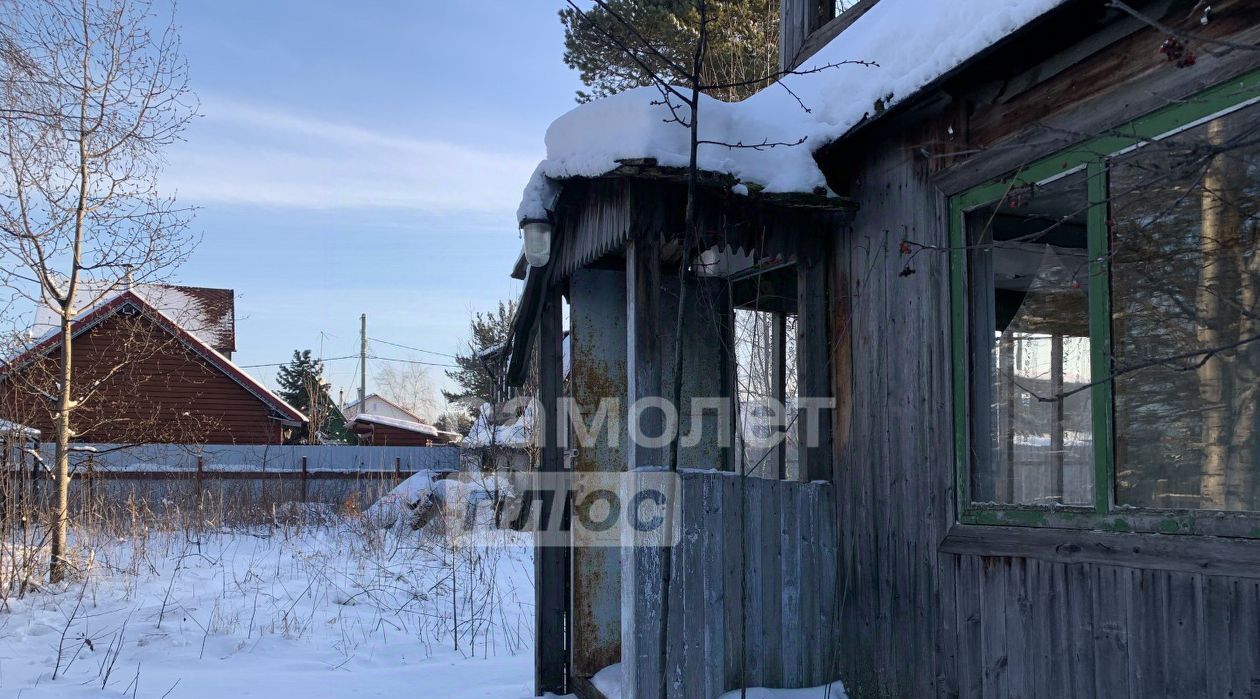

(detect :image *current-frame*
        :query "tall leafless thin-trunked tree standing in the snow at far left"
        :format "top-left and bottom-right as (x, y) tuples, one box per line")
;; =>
(0, 0), (195, 582)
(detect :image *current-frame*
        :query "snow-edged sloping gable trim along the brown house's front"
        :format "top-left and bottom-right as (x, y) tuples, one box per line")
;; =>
(4, 290), (306, 423)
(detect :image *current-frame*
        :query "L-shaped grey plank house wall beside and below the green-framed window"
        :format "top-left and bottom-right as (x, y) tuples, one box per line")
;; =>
(833, 124), (1260, 699)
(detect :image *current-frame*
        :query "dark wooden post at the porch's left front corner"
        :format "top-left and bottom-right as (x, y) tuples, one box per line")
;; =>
(534, 282), (572, 695)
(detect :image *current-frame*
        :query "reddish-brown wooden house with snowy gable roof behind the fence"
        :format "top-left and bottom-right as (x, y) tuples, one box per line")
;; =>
(0, 286), (306, 445)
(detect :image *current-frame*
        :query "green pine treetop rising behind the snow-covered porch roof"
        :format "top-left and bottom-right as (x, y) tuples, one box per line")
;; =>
(559, 0), (779, 102)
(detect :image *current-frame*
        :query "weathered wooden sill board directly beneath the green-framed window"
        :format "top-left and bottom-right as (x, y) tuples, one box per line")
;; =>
(940, 524), (1260, 578)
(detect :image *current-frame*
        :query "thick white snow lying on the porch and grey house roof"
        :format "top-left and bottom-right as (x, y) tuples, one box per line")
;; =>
(517, 0), (1066, 222)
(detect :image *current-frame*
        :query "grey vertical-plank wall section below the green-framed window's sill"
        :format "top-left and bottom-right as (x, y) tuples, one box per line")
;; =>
(937, 555), (1260, 699)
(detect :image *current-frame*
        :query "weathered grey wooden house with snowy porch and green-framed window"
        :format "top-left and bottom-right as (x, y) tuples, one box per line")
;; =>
(513, 0), (1260, 698)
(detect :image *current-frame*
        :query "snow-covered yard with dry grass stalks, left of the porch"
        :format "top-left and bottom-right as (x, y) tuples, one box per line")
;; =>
(0, 518), (533, 699)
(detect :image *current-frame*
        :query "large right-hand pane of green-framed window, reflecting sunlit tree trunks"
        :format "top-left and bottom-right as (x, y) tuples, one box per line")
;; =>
(1110, 101), (1260, 510)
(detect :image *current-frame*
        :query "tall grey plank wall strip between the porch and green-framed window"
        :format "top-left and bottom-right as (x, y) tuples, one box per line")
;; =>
(832, 128), (953, 696)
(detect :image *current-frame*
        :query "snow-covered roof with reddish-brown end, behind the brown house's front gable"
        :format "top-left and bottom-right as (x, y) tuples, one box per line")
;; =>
(32, 283), (236, 353)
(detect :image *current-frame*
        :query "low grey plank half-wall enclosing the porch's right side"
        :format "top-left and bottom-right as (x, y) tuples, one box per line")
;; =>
(625, 471), (847, 699)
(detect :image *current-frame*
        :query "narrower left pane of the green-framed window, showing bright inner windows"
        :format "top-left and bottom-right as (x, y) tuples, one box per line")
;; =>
(968, 174), (1094, 505)
